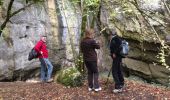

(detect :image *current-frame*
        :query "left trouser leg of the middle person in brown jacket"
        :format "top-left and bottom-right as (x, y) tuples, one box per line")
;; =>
(85, 61), (93, 88)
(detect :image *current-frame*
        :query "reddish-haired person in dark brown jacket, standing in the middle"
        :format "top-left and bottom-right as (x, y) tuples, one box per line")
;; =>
(80, 29), (101, 92)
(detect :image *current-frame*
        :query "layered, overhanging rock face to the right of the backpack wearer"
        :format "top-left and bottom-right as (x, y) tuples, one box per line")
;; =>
(100, 0), (170, 85)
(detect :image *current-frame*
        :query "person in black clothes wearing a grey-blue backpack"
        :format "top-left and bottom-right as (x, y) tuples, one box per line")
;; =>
(110, 30), (124, 93)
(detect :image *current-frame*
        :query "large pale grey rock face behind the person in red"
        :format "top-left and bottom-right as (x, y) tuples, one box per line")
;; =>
(0, 0), (81, 81)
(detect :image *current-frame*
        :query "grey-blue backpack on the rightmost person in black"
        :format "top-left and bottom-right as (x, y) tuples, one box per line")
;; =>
(120, 40), (129, 57)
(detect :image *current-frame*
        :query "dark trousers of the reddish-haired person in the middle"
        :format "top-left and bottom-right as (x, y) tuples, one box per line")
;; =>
(85, 61), (99, 89)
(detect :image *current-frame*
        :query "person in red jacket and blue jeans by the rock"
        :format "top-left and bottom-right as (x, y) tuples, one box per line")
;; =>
(34, 35), (53, 82)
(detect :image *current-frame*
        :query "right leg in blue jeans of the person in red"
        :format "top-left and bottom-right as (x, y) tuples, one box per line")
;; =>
(44, 58), (53, 80)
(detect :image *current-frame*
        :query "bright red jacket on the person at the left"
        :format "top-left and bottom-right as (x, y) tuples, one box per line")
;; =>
(34, 40), (48, 58)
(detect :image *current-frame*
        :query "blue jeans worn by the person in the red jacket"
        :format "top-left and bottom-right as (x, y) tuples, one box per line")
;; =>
(39, 58), (53, 81)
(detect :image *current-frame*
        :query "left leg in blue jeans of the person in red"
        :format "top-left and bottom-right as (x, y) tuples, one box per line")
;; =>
(39, 58), (46, 81)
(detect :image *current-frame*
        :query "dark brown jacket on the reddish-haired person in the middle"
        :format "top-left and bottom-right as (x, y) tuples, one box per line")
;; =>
(80, 37), (100, 61)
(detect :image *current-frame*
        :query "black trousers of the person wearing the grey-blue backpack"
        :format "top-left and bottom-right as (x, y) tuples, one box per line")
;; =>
(112, 56), (124, 89)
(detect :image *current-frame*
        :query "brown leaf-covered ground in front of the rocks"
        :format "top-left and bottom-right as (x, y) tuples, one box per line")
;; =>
(0, 80), (170, 100)
